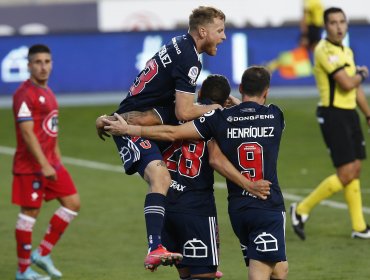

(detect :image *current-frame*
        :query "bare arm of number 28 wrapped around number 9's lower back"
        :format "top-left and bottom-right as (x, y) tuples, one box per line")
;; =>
(208, 140), (271, 200)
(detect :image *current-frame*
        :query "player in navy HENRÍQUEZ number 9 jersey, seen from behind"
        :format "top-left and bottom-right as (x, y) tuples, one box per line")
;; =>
(105, 66), (288, 280)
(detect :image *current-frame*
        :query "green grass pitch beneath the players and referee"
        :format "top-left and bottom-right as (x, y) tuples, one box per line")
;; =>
(0, 95), (370, 280)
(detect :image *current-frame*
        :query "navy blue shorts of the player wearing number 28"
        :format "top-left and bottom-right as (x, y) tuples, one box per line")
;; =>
(162, 211), (219, 274)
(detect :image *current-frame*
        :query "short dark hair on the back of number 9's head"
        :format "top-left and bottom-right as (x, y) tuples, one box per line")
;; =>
(241, 66), (271, 96)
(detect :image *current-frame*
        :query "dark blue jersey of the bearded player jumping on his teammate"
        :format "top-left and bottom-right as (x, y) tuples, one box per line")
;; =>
(117, 34), (202, 113)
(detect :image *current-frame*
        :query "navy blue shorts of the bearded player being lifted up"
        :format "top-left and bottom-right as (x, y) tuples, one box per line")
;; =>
(113, 136), (163, 177)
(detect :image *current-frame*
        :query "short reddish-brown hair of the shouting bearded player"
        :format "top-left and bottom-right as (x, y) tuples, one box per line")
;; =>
(189, 6), (226, 30)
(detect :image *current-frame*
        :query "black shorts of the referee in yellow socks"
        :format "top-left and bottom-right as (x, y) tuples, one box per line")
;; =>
(316, 107), (366, 167)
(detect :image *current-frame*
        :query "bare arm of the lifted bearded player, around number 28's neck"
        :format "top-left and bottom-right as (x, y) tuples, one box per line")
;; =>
(175, 91), (222, 121)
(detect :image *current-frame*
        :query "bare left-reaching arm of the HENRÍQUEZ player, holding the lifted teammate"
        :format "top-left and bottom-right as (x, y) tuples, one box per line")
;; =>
(103, 114), (202, 142)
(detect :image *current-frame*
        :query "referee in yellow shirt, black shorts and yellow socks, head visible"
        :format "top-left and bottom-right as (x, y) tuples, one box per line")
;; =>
(290, 8), (370, 240)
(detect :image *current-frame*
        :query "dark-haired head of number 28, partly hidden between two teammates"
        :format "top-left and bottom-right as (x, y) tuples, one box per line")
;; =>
(201, 74), (231, 106)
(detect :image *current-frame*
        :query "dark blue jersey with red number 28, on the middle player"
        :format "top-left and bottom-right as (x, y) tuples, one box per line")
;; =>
(155, 107), (216, 216)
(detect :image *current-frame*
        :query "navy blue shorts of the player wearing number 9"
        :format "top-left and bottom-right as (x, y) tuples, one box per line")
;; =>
(229, 208), (286, 266)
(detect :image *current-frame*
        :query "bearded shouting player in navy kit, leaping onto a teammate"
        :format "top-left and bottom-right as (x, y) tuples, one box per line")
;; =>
(97, 6), (226, 270)
